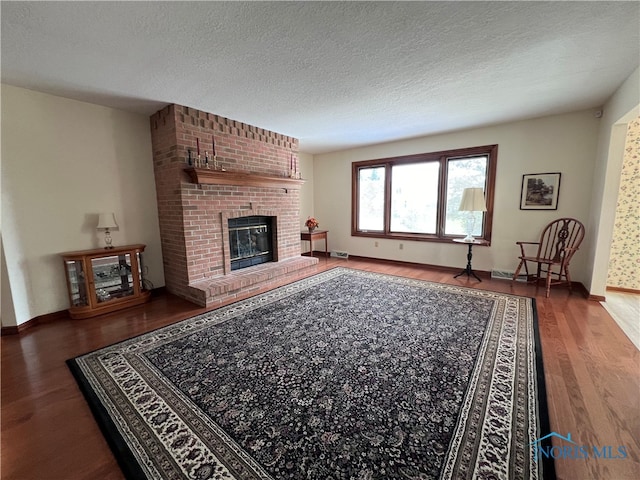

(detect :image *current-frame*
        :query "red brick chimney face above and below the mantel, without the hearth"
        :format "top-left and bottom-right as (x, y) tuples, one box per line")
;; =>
(151, 105), (300, 304)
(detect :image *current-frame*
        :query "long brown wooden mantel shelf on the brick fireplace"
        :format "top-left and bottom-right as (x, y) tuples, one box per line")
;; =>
(184, 167), (305, 190)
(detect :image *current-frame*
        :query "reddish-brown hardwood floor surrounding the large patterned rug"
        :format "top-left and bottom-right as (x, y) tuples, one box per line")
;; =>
(0, 259), (640, 480)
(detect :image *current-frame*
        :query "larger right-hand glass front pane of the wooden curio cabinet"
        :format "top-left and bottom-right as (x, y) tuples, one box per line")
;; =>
(91, 253), (135, 303)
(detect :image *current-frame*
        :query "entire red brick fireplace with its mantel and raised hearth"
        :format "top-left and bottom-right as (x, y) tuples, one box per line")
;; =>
(151, 105), (318, 307)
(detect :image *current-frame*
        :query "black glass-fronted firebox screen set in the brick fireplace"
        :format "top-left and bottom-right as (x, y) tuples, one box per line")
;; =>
(229, 216), (273, 270)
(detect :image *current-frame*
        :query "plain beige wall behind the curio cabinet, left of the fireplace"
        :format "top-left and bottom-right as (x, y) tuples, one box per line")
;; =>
(1, 85), (164, 326)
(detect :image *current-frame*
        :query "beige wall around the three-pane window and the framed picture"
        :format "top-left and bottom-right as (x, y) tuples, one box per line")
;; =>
(314, 110), (599, 283)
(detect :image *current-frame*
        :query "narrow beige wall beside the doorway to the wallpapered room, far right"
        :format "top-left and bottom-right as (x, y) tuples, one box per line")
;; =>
(585, 68), (640, 297)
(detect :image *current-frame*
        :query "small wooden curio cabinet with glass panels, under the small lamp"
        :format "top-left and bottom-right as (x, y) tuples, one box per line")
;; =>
(62, 245), (151, 318)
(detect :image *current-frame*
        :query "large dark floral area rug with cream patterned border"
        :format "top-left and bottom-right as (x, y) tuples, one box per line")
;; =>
(68, 268), (554, 480)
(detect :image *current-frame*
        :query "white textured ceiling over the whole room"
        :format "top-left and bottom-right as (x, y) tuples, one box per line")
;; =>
(1, 1), (640, 153)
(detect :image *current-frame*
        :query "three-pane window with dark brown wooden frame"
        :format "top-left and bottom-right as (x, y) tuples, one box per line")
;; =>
(351, 145), (498, 242)
